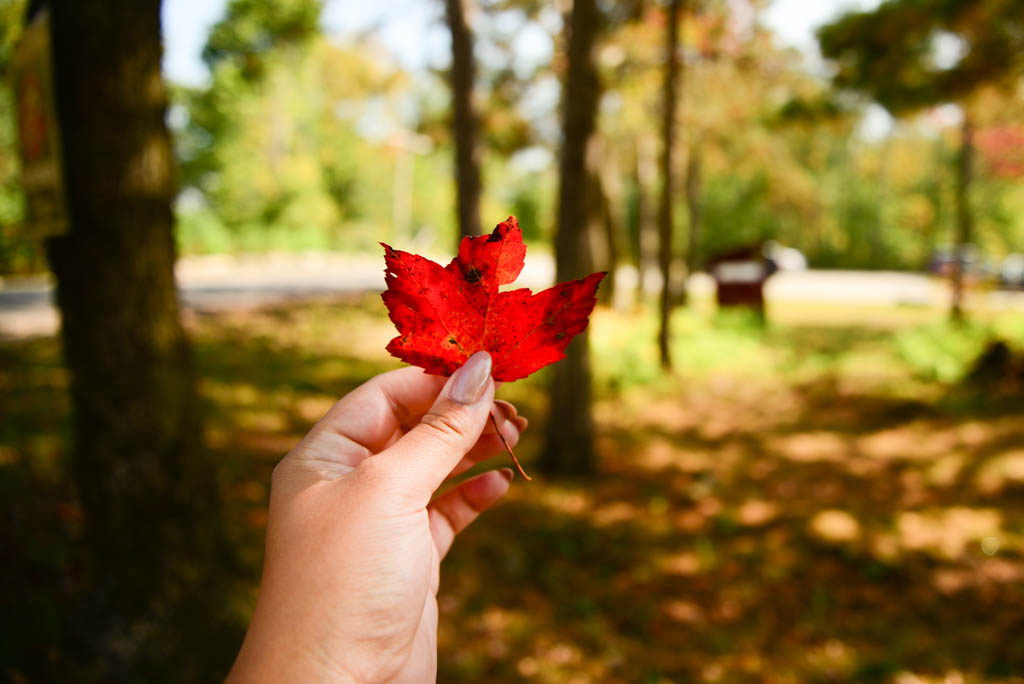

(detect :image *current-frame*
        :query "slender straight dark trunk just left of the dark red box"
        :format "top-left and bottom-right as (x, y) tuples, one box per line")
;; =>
(657, 0), (683, 369)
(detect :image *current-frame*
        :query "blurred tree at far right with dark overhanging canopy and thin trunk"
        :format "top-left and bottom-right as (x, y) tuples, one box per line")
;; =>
(818, 0), (1024, 319)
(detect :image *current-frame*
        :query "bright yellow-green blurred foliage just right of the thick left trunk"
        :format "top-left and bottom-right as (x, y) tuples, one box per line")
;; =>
(177, 0), (438, 251)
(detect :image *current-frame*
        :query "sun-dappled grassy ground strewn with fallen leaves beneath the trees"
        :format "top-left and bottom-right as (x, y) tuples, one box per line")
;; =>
(0, 298), (1024, 684)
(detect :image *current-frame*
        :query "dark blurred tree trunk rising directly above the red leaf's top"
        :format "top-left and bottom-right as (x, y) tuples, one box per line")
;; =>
(444, 0), (480, 242)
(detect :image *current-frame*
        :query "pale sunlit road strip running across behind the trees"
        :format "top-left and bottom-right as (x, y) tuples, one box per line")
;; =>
(0, 254), (1024, 339)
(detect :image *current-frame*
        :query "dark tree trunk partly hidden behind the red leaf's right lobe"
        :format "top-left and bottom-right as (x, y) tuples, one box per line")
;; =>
(540, 0), (601, 474)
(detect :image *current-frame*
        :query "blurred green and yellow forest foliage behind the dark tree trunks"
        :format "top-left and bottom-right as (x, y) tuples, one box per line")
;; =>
(0, 2), (1024, 272)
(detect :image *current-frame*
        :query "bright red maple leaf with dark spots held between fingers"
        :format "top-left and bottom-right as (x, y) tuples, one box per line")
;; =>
(382, 216), (605, 381)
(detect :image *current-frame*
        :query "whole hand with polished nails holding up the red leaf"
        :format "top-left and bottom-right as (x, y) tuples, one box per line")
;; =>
(228, 352), (526, 682)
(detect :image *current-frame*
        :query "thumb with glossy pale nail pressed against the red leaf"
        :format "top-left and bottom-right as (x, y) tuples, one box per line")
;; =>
(373, 351), (495, 504)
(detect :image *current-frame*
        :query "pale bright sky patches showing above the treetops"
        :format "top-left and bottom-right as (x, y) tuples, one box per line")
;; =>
(163, 0), (879, 85)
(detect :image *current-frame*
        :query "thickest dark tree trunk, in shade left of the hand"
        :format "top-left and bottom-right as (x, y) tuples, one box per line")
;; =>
(47, 0), (241, 681)
